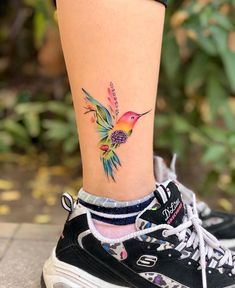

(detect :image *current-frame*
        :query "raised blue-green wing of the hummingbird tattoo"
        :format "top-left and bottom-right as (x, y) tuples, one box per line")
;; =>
(82, 88), (113, 140)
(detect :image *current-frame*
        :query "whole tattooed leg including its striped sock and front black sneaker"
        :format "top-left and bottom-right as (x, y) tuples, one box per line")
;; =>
(43, 0), (235, 288)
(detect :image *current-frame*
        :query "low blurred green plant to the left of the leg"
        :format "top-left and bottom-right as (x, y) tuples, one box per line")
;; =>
(0, 91), (78, 153)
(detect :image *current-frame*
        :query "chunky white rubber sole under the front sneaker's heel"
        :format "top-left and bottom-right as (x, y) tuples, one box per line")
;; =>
(41, 249), (130, 288)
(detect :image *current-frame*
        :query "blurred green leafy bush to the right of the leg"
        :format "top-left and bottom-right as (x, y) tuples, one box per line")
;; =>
(156, 0), (235, 193)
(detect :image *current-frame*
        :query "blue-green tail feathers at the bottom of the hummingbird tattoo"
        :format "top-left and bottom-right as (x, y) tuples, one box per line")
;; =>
(101, 150), (121, 181)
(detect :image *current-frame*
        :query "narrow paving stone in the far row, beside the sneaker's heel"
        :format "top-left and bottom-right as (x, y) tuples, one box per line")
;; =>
(14, 223), (63, 241)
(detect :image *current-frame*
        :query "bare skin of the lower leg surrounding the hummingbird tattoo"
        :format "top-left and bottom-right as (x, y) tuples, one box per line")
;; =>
(57, 0), (165, 201)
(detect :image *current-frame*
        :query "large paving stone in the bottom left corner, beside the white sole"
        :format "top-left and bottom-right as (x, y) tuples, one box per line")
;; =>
(0, 240), (55, 288)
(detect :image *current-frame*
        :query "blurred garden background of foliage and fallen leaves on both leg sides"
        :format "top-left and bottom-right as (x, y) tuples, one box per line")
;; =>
(0, 0), (235, 224)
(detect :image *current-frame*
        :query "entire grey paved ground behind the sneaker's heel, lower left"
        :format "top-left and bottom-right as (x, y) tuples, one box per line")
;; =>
(0, 223), (62, 288)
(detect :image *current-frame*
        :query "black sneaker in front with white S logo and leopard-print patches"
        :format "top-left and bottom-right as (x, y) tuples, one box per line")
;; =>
(42, 181), (235, 288)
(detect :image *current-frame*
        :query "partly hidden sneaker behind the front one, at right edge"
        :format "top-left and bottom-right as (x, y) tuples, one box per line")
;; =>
(154, 155), (235, 250)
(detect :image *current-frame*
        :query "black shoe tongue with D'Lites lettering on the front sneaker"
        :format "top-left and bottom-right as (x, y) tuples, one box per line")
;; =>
(136, 181), (185, 230)
